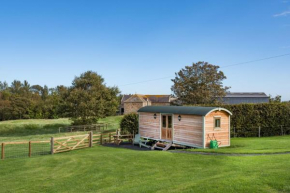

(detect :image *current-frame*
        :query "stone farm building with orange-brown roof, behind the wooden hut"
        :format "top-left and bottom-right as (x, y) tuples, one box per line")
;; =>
(120, 94), (176, 114)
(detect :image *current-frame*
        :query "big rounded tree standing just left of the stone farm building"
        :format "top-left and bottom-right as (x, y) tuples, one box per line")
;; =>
(65, 71), (119, 125)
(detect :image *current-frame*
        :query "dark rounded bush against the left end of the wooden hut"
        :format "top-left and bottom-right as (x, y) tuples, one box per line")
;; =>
(120, 113), (139, 134)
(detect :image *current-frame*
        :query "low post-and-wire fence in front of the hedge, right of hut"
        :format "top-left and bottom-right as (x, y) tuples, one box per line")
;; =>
(231, 125), (290, 137)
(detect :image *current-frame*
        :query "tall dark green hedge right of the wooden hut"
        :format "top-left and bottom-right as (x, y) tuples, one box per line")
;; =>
(191, 102), (290, 137)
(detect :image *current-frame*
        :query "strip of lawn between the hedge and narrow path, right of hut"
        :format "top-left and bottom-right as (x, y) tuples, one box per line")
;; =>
(189, 135), (290, 153)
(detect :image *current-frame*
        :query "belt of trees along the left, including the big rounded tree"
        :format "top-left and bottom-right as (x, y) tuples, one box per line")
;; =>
(0, 71), (120, 124)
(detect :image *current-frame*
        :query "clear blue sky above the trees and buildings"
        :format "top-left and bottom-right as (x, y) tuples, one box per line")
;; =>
(0, 0), (290, 100)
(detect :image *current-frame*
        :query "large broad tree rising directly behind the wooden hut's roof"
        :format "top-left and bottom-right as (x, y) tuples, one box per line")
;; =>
(171, 62), (230, 104)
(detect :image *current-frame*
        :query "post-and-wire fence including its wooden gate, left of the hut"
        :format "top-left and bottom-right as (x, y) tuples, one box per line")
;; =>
(1, 132), (116, 159)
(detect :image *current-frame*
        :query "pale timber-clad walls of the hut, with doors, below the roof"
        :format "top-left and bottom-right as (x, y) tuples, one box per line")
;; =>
(139, 110), (230, 148)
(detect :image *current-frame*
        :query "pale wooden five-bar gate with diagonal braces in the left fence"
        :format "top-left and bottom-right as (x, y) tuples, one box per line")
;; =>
(51, 133), (92, 154)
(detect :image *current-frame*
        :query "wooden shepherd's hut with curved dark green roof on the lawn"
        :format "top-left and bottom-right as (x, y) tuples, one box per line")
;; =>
(138, 106), (232, 148)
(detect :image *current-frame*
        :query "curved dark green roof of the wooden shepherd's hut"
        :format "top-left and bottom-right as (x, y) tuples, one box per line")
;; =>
(138, 106), (232, 116)
